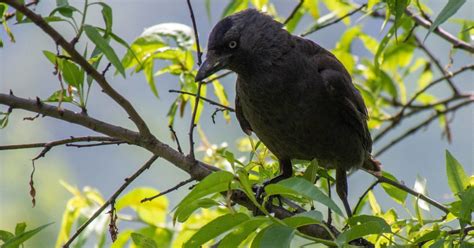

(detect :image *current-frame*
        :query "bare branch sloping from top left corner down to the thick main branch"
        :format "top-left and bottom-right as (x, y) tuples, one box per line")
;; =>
(0, 0), (151, 139)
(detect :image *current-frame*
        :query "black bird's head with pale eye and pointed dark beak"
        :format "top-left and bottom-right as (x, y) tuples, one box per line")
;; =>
(196, 9), (286, 82)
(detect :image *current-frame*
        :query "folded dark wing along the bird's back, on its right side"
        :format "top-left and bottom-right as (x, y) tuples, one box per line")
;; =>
(305, 40), (372, 153)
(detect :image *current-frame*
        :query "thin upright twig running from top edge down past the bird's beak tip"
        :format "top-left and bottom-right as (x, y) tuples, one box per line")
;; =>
(186, 0), (202, 160)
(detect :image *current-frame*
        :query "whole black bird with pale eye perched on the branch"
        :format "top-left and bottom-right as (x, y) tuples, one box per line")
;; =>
(196, 9), (380, 216)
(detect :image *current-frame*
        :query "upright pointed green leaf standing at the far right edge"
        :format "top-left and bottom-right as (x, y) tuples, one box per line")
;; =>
(446, 150), (469, 194)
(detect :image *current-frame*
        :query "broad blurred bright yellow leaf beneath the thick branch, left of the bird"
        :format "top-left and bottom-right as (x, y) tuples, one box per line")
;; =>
(115, 187), (168, 226)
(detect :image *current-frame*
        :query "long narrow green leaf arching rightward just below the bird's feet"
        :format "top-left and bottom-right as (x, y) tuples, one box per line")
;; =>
(265, 177), (343, 216)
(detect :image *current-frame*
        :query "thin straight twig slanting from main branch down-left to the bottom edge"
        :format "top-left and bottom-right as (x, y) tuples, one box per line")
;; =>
(63, 155), (158, 248)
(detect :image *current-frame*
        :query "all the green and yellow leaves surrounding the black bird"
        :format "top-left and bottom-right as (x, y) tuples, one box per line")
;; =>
(0, 0), (474, 248)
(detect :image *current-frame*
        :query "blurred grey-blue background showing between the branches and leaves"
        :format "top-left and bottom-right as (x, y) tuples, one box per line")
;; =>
(0, 0), (474, 247)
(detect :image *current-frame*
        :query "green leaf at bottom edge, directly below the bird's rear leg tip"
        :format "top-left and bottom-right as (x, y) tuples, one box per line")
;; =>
(336, 215), (391, 245)
